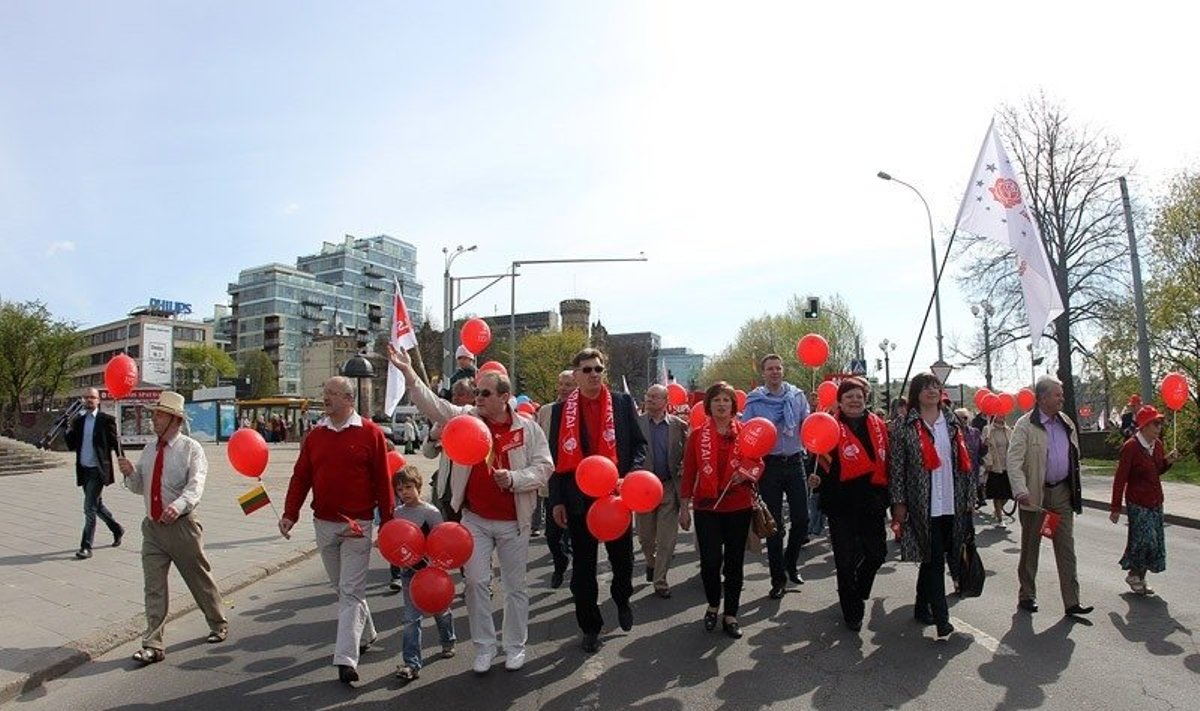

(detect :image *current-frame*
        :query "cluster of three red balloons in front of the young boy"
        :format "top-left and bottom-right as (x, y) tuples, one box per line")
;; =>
(376, 519), (475, 615)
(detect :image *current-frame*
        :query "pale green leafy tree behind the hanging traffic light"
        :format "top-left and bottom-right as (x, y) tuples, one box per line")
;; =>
(700, 294), (860, 390)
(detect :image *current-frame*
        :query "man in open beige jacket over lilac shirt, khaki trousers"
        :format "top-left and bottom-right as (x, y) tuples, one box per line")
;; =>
(1006, 376), (1092, 617)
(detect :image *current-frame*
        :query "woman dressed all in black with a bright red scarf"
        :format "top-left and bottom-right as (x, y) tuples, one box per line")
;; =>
(809, 377), (888, 632)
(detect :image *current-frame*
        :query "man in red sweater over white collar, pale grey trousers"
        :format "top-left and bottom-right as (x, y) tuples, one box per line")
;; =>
(280, 376), (392, 683)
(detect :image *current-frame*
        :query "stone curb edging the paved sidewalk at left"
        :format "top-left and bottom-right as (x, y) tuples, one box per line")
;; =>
(0, 544), (317, 706)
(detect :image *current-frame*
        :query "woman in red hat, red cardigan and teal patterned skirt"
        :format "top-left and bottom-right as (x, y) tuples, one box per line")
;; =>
(1109, 405), (1180, 595)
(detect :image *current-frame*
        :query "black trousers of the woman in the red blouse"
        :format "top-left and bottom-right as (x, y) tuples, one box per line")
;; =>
(695, 509), (750, 617)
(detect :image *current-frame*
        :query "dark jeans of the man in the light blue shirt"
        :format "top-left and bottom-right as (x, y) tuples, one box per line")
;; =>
(758, 454), (809, 585)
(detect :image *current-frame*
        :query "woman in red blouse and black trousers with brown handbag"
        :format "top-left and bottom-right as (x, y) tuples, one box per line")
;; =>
(679, 382), (762, 639)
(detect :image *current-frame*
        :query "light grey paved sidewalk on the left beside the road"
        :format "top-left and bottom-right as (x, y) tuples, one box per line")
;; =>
(0, 443), (436, 704)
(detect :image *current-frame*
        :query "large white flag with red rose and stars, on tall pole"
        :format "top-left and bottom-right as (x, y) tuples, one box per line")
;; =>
(955, 121), (1062, 348)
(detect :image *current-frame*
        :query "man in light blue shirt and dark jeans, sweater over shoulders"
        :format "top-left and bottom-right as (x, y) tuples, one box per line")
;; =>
(742, 353), (809, 599)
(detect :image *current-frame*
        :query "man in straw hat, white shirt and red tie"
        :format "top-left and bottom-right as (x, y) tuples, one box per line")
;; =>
(116, 390), (229, 665)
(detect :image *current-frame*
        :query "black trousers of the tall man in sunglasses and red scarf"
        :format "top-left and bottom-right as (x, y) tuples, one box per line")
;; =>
(566, 513), (634, 634)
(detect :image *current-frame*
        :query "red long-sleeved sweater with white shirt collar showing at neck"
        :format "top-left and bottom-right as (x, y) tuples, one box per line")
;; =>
(283, 419), (392, 524)
